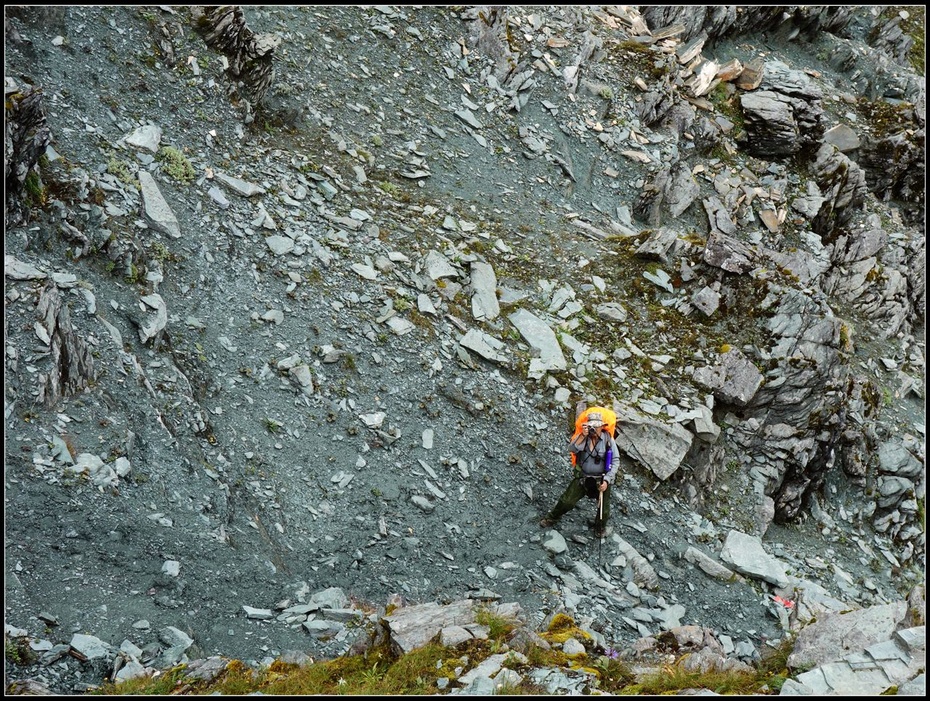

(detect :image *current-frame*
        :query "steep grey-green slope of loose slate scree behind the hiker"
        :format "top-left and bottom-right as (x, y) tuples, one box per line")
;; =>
(4, 6), (925, 693)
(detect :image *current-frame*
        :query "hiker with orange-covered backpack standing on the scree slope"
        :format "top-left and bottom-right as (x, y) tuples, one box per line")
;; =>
(539, 411), (620, 538)
